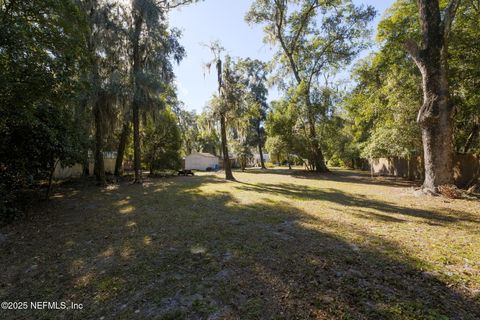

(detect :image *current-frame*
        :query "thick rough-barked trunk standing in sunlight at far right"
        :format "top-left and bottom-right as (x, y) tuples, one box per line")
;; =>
(405, 0), (460, 193)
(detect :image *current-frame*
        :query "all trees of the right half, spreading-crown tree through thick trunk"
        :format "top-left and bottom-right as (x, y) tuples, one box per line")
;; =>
(246, 0), (480, 193)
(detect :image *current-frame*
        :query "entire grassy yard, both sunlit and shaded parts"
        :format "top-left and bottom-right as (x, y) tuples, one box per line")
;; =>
(0, 169), (480, 319)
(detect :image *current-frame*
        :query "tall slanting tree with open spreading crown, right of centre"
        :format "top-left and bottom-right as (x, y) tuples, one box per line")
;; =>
(246, 0), (375, 172)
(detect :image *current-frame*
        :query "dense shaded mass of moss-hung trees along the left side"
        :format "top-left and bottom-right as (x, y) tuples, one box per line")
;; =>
(0, 0), (198, 215)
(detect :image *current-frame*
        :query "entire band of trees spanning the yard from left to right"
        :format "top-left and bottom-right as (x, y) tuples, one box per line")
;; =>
(0, 0), (480, 219)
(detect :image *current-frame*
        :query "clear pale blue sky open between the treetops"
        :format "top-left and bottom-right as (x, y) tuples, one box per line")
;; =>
(170, 0), (394, 112)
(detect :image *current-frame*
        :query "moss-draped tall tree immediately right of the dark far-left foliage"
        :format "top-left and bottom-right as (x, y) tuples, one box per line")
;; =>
(79, 0), (128, 185)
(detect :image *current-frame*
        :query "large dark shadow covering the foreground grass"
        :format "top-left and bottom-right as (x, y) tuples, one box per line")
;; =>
(0, 177), (480, 319)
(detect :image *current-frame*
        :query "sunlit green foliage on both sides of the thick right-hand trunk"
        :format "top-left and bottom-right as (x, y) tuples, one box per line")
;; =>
(344, 0), (480, 165)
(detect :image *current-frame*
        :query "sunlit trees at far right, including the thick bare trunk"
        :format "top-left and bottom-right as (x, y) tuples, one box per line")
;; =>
(340, 0), (480, 192)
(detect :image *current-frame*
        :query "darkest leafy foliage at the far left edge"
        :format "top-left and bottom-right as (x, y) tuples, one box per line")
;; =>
(0, 0), (85, 216)
